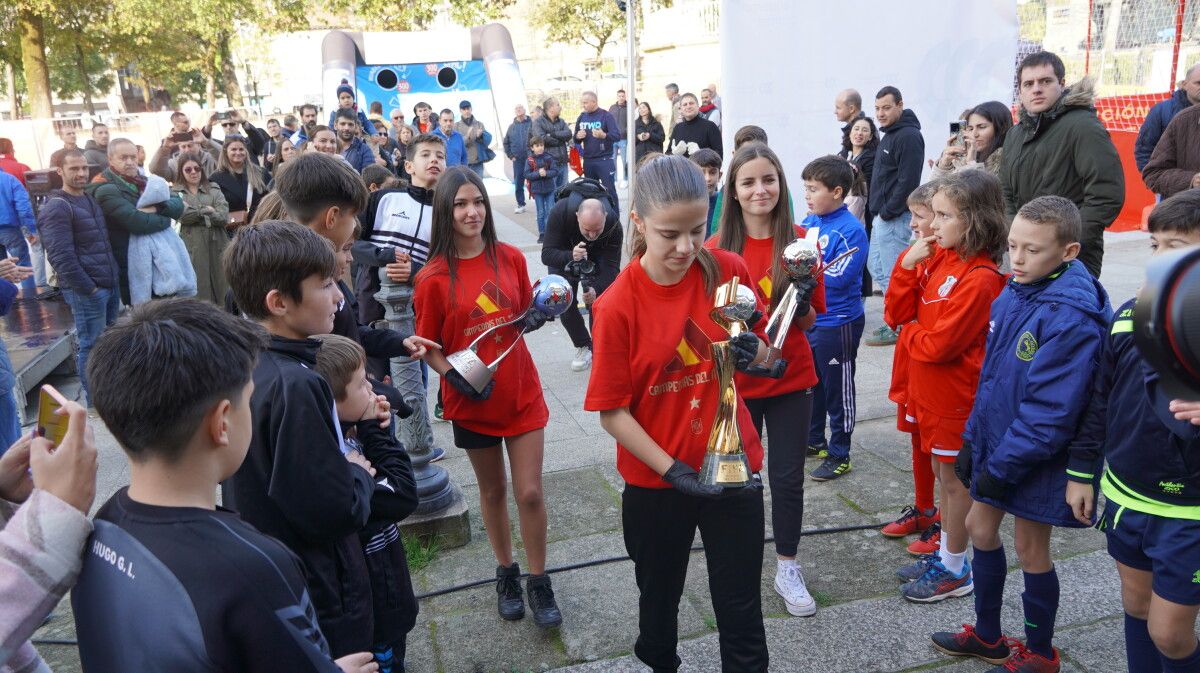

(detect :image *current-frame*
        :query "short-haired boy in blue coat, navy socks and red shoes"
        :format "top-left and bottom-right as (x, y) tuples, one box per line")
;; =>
(932, 197), (1111, 673)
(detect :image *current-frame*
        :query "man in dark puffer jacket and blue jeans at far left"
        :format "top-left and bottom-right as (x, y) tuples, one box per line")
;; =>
(37, 149), (121, 398)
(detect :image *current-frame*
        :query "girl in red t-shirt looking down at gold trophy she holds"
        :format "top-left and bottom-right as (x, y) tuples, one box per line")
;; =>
(585, 156), (768, 673)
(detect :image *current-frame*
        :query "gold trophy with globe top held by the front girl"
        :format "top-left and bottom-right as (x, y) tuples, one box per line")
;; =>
(700, 276), (757, 488)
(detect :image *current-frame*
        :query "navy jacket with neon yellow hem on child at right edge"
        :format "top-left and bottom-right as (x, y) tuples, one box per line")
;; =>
(1067, 299), (1200, 513)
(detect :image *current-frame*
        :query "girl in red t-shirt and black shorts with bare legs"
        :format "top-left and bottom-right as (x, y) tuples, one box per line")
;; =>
(413, 167), (563, 627)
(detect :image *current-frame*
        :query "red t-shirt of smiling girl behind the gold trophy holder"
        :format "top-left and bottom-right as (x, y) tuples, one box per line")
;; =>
(704, 224), (826, 399)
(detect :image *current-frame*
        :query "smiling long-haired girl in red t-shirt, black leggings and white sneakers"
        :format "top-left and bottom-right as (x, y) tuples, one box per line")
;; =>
(706, 143), (824, 617)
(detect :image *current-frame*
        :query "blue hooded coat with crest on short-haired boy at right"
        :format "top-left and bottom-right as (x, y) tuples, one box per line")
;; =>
(964, 260), (1112, 528)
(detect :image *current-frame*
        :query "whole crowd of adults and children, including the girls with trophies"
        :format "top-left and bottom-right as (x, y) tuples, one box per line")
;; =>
(0, 52), (1200, 673)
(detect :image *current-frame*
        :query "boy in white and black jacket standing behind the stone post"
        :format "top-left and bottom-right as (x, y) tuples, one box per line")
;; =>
(360, 133), (446, 325)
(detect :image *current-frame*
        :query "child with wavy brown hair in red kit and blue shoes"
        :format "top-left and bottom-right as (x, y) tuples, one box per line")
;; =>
(883, 170), (1008, 602)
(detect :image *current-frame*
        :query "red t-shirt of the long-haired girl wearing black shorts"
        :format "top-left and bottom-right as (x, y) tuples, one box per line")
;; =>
(413, 244), (550, 437)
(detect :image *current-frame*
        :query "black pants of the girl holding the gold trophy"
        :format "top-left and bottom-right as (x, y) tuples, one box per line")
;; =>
(620, 485), (767, 673)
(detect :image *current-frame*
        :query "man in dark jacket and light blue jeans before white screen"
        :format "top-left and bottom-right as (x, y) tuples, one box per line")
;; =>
(865, 86), (925, 345)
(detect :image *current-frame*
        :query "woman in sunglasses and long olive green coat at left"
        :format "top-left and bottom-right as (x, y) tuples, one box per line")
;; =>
(172, 152), (229, 306)
